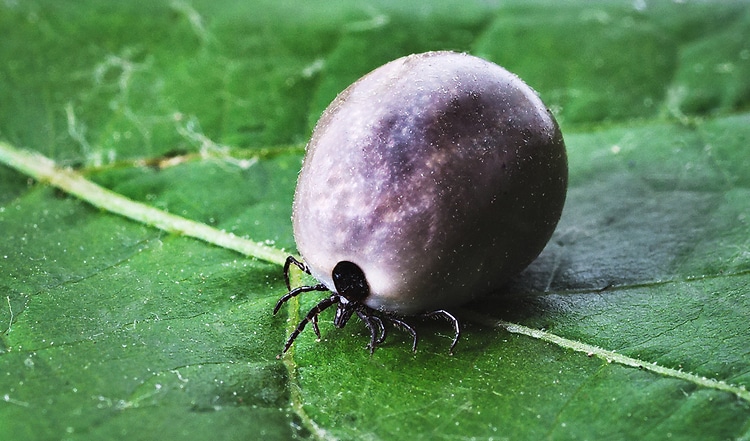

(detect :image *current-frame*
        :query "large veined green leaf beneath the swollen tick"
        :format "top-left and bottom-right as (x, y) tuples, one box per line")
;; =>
(0, 0), (750, 440)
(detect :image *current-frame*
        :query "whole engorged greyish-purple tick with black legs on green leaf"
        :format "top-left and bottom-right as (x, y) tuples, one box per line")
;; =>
(276, 52), (567, 350)
